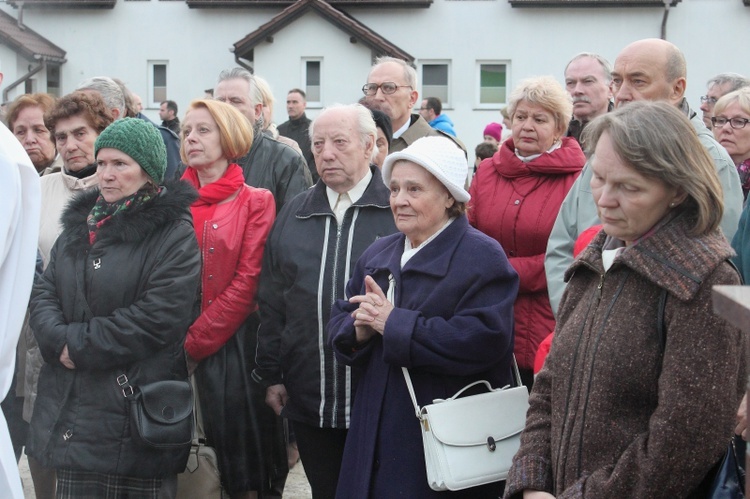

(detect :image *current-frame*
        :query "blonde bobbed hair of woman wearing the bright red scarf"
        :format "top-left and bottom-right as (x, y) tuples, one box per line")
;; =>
(180, 99), (254, 165)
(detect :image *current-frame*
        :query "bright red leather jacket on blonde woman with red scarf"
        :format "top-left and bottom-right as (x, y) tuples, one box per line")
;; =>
(185, 185), (276, 360)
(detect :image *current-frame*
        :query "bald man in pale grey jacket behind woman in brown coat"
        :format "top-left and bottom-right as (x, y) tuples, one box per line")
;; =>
(544, 38), (743, 313)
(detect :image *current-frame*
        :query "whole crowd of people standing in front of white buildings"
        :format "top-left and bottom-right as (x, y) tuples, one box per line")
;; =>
(0, 35), (750, 499)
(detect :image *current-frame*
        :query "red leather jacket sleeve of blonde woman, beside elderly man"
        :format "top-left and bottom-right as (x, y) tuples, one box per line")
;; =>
(185, 190), (276, 360)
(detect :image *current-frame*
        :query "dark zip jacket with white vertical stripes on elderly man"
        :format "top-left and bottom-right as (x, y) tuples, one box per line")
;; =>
(253, 166), (396, 429)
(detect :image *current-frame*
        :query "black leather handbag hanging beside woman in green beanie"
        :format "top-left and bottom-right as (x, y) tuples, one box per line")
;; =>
(117, 374), (193, 448)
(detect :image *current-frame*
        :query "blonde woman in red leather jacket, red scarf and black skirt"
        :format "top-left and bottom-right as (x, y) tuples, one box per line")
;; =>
(180, 100), (276, 499)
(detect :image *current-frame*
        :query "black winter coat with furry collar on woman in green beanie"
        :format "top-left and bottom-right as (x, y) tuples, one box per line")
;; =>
(28, 182), (200, 478)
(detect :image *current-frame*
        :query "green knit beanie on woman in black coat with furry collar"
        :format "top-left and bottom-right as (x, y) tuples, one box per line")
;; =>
(94, 118), (167, 184)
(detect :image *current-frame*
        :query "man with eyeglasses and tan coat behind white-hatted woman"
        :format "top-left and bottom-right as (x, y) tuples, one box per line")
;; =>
(362, 57), (466, 154)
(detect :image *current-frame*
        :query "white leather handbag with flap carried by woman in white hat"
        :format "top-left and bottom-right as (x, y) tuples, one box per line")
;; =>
(402, 358), (529, 490)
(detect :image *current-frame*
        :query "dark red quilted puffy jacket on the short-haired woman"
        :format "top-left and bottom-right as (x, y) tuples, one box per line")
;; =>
(468, 137), (586, 369)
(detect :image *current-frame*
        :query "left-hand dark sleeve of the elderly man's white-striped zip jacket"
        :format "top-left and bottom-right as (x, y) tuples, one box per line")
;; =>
(253, 206), (294, 387)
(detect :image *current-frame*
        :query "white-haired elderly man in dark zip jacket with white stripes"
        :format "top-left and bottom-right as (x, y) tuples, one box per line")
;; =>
(253, 104), (396, 497)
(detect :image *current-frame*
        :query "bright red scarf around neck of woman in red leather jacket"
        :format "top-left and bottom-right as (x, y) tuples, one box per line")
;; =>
(182, 163), (245, 248)
